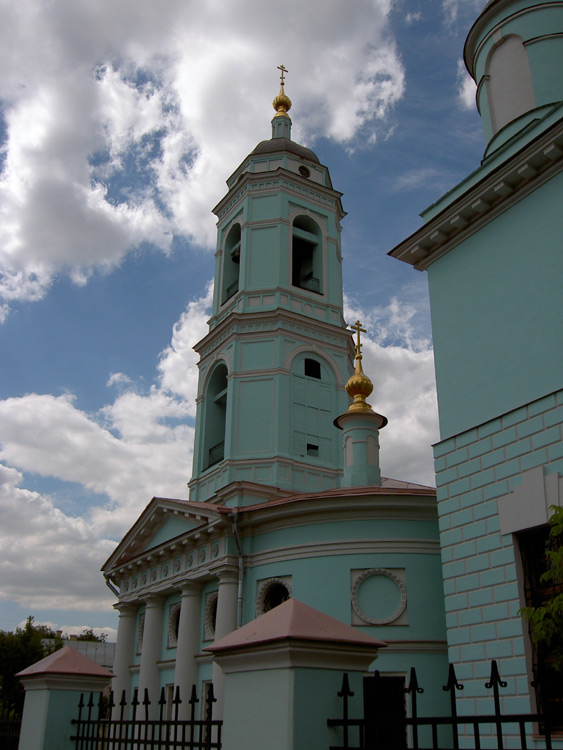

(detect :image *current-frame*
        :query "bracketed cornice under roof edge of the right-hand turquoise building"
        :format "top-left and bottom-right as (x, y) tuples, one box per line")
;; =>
(388, 120), (563, 271)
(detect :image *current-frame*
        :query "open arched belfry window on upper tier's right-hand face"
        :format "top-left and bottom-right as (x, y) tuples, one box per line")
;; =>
(291, 216), (323, 294)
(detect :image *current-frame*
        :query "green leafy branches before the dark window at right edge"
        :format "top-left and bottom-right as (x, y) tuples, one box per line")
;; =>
(520, 506), (563, 672)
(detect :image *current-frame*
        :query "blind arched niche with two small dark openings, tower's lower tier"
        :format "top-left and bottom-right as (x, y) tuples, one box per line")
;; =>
(291, 355), (336, 463)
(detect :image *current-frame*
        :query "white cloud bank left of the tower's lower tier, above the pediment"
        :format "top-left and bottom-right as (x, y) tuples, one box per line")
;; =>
(0, 287), (214, 616)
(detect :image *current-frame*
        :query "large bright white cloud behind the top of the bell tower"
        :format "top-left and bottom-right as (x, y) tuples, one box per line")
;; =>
(0, 0), (404, 312)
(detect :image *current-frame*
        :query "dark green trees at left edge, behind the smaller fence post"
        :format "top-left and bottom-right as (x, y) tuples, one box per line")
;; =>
(0, 616), (62, 707)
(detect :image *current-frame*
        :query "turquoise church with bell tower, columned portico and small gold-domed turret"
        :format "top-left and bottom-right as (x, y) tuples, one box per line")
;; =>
(103, 66), (448, 715)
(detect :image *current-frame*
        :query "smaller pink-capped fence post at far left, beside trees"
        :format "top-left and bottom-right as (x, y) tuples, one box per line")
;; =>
(16, 646), (113, 750)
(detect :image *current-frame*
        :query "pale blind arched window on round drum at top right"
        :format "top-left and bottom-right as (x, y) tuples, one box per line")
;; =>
(486, 36), (536, 133)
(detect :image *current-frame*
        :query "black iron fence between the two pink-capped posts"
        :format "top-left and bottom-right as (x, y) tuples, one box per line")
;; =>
(71, 684), (222, 750)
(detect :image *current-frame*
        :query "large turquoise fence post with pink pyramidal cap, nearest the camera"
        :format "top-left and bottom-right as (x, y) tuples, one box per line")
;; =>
(206, 599), (385, 750)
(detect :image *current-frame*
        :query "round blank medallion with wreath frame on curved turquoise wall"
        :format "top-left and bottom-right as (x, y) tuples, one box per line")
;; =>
(352, 568), (407, 625)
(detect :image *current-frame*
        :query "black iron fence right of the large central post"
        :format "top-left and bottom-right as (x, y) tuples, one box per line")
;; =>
(328, 661), (557, 750)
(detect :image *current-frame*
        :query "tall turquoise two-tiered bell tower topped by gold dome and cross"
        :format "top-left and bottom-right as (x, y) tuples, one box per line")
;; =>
(189, 65), (353, 505)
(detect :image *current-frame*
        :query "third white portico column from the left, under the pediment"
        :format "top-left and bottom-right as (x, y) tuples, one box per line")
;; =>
(174, 583), (205, 719)
